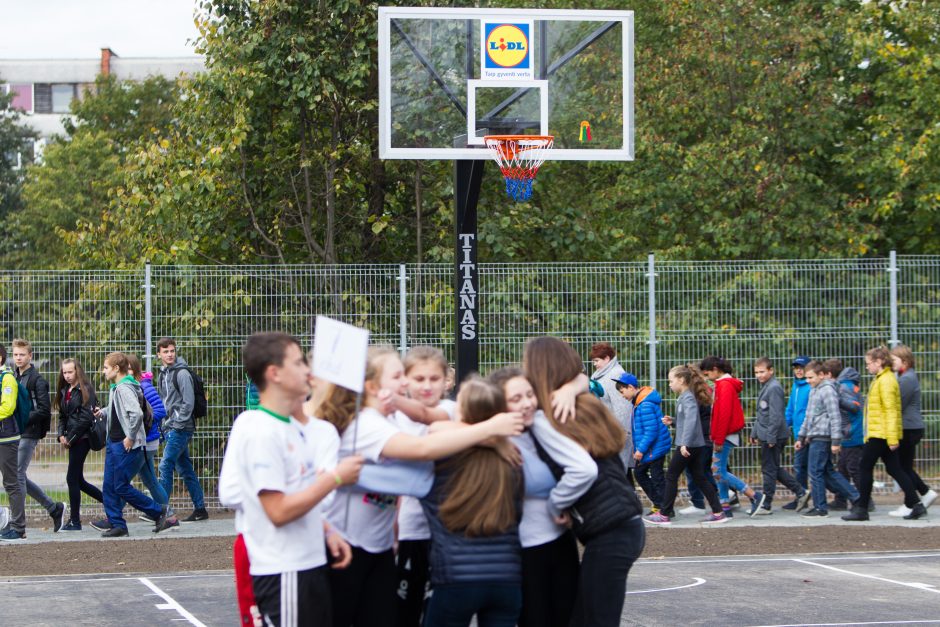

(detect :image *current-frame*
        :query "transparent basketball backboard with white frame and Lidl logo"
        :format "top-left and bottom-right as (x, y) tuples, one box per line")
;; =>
(378, 7), (633, 161)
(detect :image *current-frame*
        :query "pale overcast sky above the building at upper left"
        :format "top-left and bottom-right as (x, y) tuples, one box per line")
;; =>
(0, 0), (197, 59)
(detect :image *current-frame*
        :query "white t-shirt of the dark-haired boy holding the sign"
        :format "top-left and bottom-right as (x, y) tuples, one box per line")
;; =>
(219, 409), (326, 575)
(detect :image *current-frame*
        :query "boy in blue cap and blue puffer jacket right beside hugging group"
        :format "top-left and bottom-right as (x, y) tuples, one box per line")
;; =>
(614, 372), (672, 513)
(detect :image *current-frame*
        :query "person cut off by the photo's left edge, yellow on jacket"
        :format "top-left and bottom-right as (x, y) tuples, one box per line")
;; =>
(0, 344), (26, 542)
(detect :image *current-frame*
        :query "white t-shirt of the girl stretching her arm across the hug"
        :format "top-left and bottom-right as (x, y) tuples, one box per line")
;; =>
(325, 407), (401, 553)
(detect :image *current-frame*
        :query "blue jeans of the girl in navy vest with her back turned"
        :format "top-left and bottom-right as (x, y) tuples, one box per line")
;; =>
(424, 583), (522, 627)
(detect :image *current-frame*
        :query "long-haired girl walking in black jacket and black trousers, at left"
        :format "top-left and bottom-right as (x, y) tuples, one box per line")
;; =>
(55, 358), (104, 531)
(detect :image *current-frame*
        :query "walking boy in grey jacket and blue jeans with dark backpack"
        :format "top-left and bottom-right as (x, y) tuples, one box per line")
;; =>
(157, 337), (209, 522)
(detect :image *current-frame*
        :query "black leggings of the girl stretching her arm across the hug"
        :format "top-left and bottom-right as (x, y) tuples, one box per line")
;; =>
(330, 546), (398, 627)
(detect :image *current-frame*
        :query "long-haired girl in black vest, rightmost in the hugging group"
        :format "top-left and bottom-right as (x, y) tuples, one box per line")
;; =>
(523, 337), (646, 627)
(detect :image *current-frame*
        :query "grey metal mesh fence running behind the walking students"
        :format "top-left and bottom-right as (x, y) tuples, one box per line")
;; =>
(0, 257), (940, 515)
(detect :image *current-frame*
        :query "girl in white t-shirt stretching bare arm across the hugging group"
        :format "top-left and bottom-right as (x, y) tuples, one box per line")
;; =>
(315, 346), (522, 627)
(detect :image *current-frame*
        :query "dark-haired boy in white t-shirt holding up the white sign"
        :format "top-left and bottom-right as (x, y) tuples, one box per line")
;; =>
(219, 333), (362, 627)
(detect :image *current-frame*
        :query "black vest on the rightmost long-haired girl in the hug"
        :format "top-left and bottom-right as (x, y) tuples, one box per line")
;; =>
(532, 433), (643, 543)
